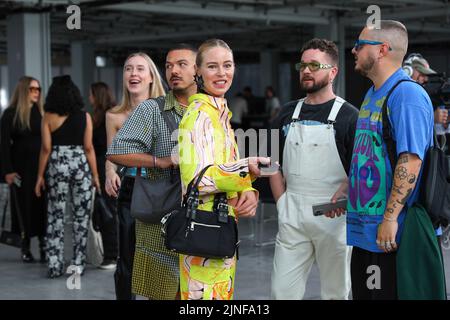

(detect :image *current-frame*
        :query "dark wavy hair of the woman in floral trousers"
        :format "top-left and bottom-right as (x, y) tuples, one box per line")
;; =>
(44, 75), (84, 116)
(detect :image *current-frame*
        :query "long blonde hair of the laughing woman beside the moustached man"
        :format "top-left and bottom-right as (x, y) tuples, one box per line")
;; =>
(109, 52), (166, 113)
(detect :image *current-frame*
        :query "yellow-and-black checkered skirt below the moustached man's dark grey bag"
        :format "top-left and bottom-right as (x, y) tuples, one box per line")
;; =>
(132, 220), (180, 300)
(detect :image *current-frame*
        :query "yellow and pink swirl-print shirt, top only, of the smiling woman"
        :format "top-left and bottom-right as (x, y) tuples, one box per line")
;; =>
(178, 93), (254, 214)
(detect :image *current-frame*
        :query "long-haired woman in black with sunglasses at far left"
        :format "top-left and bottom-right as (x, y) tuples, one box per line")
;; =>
(0, 76), (47, 262)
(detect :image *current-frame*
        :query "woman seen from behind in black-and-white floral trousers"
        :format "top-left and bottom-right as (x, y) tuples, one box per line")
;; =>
(35, 76), (100, 278)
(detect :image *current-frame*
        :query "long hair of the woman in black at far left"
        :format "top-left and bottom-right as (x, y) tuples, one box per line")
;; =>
(9, 76), (44, 130)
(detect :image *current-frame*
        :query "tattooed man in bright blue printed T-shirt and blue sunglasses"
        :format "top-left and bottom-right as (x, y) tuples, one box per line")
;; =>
(338, 20), (433, 300)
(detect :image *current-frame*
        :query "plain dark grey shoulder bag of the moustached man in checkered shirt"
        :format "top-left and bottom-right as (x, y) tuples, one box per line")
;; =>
(130, 97), (181, 224)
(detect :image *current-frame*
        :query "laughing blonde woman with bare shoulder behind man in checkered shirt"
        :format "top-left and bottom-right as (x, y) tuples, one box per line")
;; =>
(105, 52), (165, 300)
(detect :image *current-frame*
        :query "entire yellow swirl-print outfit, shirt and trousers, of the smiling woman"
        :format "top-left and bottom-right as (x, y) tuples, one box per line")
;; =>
(178, 94), (255, 300)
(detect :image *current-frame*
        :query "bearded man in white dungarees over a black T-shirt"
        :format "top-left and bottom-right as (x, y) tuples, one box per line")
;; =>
(270, 39), (358, 299)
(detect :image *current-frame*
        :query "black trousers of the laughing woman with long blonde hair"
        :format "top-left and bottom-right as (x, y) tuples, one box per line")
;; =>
(114, 176), (136, 300)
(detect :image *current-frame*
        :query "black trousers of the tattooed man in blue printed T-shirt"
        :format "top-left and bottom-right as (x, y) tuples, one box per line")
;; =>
(350, 247), (398, 300)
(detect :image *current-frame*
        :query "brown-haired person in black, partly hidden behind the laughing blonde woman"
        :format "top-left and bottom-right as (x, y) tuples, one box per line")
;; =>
(89, 82), (118, 269)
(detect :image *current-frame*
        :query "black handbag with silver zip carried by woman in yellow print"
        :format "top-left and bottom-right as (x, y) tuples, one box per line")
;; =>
(161, 166), (239, 259)
